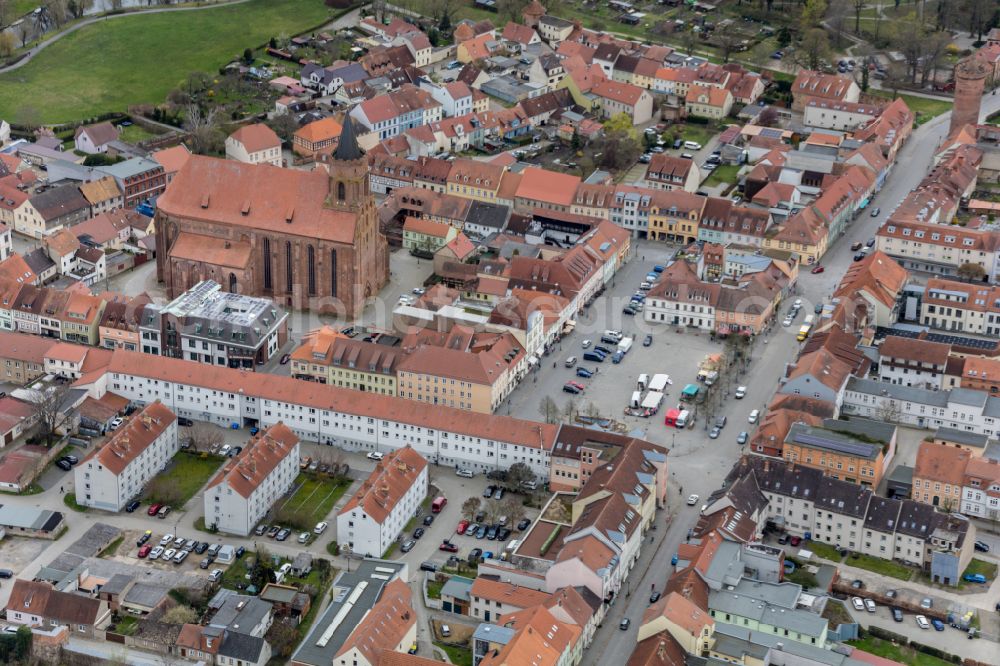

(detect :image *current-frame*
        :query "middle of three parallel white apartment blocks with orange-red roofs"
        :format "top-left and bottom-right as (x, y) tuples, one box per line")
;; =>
(205, 422), (299, 536)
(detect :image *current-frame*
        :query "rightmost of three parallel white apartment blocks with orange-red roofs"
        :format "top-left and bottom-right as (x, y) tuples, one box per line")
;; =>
(337, 446), (427, 557)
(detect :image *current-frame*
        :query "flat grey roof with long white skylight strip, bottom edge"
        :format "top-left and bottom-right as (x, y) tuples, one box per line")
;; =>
(292, 559), (406, 666)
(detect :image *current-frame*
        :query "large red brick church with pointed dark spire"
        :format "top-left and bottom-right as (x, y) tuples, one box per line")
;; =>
(156, 122), (389, 318)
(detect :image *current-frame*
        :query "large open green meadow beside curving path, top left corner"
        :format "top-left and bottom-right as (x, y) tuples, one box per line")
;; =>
(0, 0), (331, 123)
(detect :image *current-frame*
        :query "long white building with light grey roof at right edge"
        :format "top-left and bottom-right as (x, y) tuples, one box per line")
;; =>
(840, 377), (1000, 437)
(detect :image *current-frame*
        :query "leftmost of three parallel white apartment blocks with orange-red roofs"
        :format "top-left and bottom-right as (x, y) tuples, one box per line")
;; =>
(74, 401), (178, 511)
